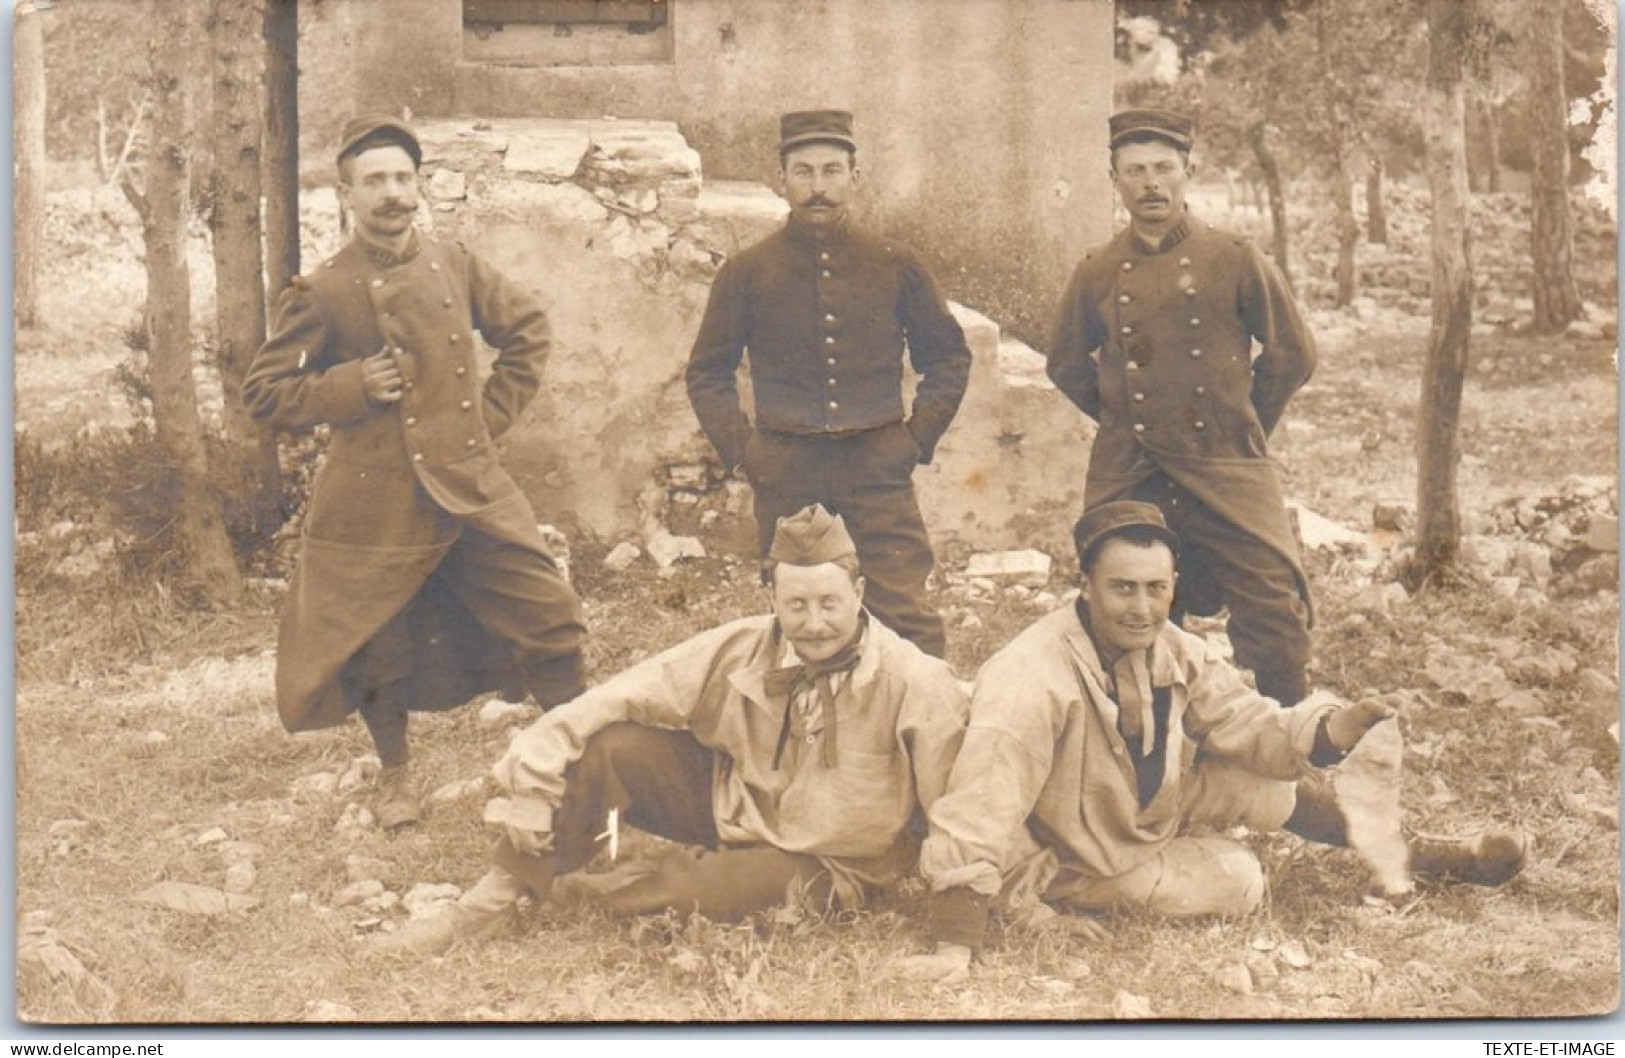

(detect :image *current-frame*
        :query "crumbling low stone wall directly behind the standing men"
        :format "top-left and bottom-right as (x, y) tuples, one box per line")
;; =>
(399, 119), (1087, 553)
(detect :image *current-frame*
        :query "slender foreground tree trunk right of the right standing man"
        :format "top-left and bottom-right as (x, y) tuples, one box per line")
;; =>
(1411, 0), (1474, 583)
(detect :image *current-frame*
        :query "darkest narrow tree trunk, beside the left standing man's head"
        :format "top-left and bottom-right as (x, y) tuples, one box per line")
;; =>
(263, 0), (299, 304)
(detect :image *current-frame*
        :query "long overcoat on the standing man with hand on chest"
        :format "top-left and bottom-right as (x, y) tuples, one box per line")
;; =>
(244, 236), (553, 730)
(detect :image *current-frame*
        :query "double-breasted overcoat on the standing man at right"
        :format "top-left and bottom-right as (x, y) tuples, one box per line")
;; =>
(1048, 218), (1315, 605)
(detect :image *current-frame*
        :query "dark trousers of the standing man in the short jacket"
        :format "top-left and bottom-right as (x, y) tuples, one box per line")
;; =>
(746, 423), (947, 657)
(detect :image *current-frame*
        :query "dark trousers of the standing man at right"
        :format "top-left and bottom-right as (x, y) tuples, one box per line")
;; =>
(1129, 473), (1310, 705)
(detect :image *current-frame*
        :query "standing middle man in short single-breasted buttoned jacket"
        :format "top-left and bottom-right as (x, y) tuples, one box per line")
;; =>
(687, 111), (970, 657)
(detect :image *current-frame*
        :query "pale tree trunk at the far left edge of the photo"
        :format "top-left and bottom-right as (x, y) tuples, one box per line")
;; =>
(11, 0), (46, 327)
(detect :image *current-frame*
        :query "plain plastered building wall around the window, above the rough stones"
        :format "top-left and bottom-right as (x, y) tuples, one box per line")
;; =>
(301, 0), (1113, 338)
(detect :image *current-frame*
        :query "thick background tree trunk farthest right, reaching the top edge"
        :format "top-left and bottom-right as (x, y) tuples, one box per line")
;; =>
(1529, 3), (1580, 335)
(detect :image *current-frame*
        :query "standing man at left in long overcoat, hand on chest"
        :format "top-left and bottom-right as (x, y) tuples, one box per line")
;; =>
(244, 117), (585, 827)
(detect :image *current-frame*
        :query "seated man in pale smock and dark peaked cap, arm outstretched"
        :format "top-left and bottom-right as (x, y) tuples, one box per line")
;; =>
(897, 501), (1524, 978)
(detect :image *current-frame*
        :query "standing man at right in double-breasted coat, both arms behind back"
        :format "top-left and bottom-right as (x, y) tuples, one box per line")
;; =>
(1048, 111), (1315, 705)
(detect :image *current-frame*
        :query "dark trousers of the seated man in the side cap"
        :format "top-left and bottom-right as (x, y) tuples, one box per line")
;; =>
(492, 723), (830, 921)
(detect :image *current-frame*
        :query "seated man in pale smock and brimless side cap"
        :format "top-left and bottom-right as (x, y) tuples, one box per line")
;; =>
(372, 504), (967, 954)
